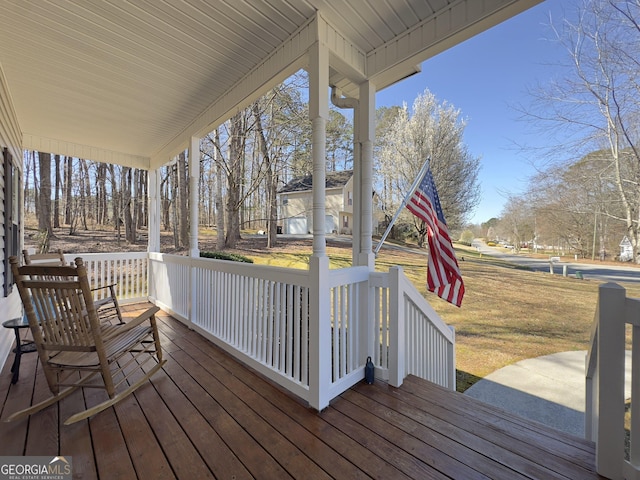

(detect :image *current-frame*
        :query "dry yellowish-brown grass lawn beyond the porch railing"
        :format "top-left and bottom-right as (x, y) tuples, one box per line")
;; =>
(244, 238), (640, 391)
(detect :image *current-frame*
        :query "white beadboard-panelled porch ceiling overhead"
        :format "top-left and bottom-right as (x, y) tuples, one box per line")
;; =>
(0, 0), (540, 168)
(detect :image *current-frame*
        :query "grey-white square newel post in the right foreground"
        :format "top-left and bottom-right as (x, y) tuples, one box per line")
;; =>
(593, 283), (626, 478)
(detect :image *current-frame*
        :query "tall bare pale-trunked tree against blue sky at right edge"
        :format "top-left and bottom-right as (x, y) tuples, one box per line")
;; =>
(527, 0), (640, 260)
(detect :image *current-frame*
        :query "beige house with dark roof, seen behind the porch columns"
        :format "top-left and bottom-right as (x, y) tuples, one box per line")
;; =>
(278, 170), (381, 235)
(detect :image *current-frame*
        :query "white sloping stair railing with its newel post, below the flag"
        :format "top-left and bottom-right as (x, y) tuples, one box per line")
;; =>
(371, 267), (456, 390)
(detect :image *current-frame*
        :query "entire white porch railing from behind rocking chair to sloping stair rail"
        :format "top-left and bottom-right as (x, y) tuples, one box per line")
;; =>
(74, 253), (455, 410)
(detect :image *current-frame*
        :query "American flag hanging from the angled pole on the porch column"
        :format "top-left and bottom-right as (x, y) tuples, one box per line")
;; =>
(407, 167), (464, 307)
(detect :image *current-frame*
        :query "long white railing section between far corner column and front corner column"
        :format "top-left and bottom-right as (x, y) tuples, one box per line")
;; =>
(149, 253), (316, 400)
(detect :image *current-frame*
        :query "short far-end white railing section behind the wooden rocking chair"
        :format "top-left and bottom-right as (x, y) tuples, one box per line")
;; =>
(64, 252), (149, 304)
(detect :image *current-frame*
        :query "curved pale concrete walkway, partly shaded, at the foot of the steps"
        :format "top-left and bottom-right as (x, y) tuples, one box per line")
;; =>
(465, 351), (631, 437)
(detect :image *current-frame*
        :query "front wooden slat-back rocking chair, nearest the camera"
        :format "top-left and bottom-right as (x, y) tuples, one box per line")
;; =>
(6, 257), (166, 425)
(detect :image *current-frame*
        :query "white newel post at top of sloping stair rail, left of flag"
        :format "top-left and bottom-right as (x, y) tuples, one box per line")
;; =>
(389, 267), (406, 387)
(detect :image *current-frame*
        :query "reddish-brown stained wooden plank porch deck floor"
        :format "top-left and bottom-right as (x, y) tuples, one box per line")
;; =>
(0, 306), (599, 480)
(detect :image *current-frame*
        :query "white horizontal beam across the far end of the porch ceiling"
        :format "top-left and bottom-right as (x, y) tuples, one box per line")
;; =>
(22, 133), (150, 170)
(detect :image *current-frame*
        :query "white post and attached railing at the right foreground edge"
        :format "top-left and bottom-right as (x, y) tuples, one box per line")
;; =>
(585, 283), (640, 479)
